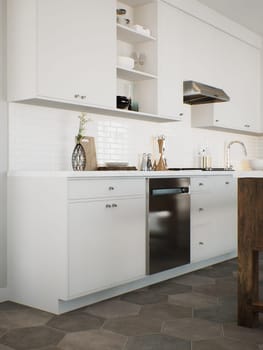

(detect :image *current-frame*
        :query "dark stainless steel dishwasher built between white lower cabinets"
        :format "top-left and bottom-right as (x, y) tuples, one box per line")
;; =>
(147, 178), (190, 274)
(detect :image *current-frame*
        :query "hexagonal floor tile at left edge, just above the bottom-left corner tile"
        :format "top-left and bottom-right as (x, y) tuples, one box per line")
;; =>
(0, 308), (53, 329)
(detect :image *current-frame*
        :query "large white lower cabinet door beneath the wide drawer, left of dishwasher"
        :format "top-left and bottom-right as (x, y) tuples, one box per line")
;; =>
(68, 197), (145, 297)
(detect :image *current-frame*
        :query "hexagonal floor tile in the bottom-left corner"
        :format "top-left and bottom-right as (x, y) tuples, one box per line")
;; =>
(0, 327), (65, 350)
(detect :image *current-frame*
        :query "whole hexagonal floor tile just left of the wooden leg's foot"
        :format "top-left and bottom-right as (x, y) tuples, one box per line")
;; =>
(165, 318), (223, 340)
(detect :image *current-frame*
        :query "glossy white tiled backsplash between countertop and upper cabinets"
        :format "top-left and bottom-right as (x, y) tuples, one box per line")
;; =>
(9, 104), (259, 170)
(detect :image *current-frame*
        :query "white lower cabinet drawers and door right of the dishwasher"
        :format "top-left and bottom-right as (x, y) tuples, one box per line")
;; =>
(191, 175), (237, 262)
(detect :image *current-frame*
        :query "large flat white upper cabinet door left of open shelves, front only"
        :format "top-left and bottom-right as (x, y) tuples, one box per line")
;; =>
(36, 0), (116, 107)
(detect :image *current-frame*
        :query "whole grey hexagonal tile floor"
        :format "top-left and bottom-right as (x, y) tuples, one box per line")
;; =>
(0, 259), (263, 350)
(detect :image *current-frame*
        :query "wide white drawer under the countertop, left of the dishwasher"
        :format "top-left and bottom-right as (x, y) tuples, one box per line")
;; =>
(68, 179), (145, 199)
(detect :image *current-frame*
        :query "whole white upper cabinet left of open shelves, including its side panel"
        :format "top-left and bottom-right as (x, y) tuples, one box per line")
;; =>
(8, 0), (116, 107)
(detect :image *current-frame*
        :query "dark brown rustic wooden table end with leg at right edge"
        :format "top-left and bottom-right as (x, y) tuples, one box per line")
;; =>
(238, 177), (263, 327)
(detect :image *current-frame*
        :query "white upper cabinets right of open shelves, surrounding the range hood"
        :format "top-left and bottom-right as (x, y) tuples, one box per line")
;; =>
(158, 2), (261, 133)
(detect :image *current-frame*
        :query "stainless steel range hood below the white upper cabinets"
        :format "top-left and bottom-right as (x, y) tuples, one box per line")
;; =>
(184, 80), (230, 105)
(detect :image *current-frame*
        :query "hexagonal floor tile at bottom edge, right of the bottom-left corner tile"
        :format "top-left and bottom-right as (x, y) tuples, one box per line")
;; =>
(59, 330), (127, 350)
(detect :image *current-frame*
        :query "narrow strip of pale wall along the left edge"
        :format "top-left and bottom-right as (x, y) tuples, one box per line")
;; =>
(0, 0), (7, 301)
